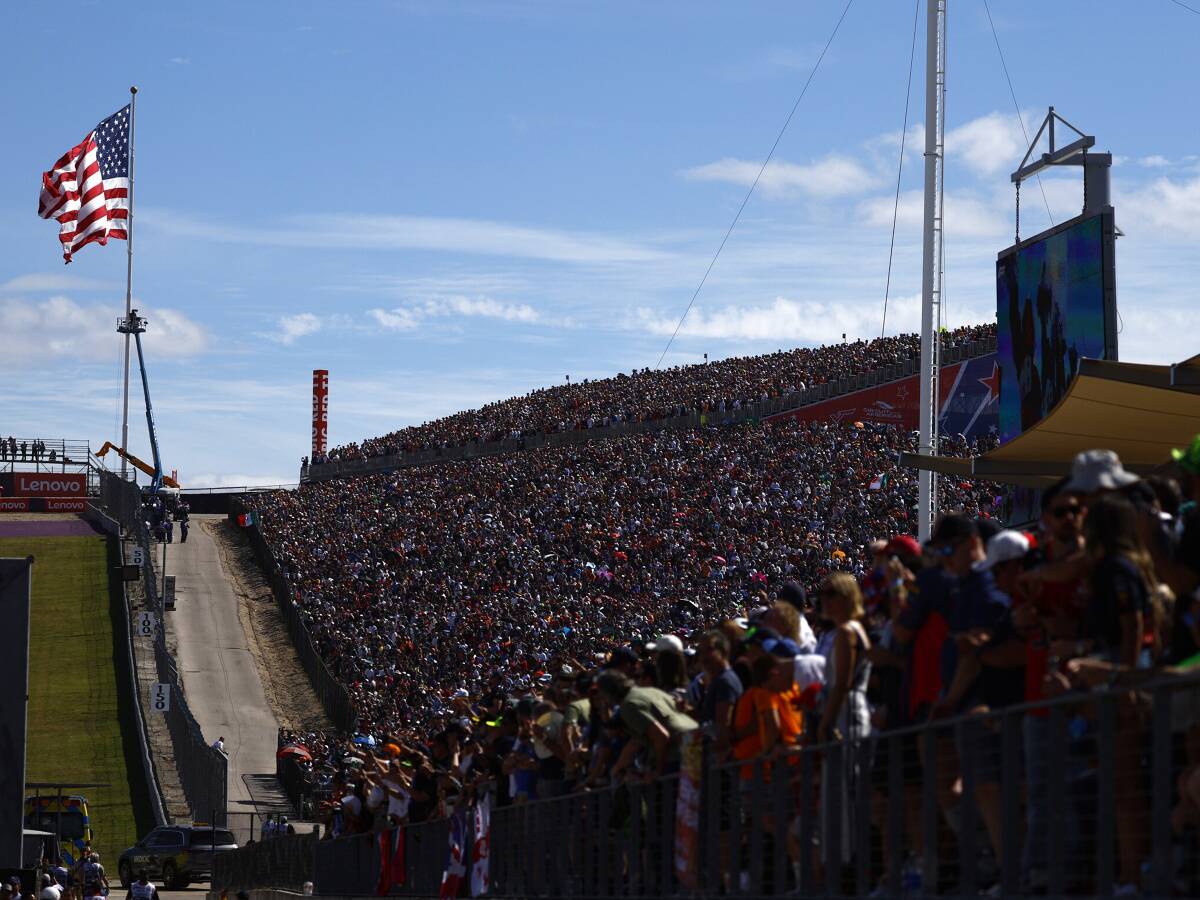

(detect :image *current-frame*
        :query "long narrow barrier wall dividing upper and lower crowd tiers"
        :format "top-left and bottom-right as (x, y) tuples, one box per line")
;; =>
(300, 337), (996, 482)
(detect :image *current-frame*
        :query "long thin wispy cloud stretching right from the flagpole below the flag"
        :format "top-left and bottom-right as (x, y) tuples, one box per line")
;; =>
(145, 209), (666, 264)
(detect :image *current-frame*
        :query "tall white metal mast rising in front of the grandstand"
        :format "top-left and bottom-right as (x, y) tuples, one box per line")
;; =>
(917, 0), (948, 541)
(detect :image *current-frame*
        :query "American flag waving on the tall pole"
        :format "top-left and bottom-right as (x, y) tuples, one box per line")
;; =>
(37, 106), (130, 263)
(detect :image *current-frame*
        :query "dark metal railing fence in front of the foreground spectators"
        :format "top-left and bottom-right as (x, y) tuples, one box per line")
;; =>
(220, 673), (1200, 899)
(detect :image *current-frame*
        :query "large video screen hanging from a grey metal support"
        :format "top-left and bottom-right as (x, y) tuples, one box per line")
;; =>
(996, 209), (1116, 442)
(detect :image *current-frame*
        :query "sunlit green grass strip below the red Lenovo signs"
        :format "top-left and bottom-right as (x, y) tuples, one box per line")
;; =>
(0, 535), (154, 872)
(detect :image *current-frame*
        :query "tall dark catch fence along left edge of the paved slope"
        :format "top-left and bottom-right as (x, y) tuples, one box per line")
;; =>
(100, 472), (228, 826)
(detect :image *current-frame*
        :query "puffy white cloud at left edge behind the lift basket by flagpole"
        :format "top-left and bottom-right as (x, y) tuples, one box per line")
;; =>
(0, 296), (208, 365)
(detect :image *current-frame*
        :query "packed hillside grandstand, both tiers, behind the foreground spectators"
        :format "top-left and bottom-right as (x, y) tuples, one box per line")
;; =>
(246, 326), (1001, 733)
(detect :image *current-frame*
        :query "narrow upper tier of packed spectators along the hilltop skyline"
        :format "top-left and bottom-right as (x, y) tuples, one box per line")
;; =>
(312, 325), (996, 464)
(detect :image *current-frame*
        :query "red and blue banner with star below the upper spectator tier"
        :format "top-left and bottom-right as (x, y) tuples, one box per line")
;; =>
(770, 353), (1000, 439)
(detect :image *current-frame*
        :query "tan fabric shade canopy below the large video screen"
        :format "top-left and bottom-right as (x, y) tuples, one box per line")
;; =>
(900, 356), (1200, 487)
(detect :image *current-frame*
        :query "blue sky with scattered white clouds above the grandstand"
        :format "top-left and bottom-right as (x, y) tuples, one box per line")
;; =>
(0, 0), (1200, 486)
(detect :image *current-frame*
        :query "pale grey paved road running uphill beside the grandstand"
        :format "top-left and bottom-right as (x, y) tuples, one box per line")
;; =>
(166, 516), (278, 812)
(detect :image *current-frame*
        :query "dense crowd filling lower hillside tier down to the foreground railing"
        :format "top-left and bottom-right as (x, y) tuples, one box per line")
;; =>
(263, 436), (1200, 895)
